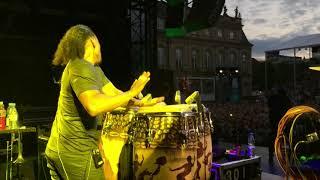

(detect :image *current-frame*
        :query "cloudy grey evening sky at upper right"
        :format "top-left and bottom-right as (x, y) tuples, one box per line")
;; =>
(226, 0), (320, 60)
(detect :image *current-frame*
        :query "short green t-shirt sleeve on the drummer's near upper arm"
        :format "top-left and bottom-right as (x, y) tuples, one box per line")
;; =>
(69, 60), (100, 97)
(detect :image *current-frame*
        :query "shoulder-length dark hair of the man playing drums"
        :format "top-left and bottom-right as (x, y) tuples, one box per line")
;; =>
(52, 24), (95, 66)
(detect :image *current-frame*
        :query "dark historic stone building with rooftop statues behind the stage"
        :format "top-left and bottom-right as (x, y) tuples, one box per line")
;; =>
(158, 3), (252, 101)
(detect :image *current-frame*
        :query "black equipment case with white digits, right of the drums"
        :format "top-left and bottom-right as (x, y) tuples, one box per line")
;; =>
(211, 156), (261, 180)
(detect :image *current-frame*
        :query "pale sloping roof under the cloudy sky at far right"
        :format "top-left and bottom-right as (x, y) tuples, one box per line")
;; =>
(265, 34), (320, 52)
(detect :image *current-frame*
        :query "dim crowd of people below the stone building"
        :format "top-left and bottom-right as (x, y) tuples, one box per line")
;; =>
(206, 99), (270, 145)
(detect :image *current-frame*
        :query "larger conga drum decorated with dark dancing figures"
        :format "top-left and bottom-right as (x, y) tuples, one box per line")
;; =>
(132, 104), (212, 180)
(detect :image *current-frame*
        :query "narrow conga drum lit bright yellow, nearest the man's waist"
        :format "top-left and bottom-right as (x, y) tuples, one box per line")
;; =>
(101, 108), (135, 180)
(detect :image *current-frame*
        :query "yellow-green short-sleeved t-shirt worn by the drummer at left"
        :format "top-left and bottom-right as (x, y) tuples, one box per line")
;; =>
(47, 59), (110, 154)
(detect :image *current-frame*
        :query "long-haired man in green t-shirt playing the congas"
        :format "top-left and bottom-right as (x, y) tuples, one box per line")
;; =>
(45, 25), (163, 180)
